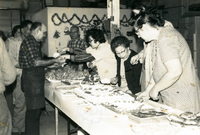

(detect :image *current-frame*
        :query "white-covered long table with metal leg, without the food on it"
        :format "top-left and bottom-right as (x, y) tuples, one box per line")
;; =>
(45, 82), (200, 135)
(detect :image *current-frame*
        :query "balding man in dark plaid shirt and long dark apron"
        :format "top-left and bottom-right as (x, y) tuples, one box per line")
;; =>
(19, 22), (65, 135)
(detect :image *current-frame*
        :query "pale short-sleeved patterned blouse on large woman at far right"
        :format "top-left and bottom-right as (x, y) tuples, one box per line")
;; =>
(152, 27), (200, 113)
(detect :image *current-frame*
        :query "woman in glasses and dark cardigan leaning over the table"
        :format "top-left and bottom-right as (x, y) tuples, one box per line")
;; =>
(111, 36), (142, 94)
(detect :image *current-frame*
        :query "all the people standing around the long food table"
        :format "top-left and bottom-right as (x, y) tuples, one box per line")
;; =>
(0, 3), (200, 135)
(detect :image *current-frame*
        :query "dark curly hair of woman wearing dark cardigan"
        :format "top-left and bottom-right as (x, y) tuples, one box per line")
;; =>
(111, 36), (130, 53)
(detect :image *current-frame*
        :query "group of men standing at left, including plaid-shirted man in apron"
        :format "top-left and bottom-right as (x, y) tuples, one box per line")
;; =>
(0, 20), (65, 135)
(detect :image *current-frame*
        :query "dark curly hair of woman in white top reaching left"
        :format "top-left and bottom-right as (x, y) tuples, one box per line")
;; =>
(85, 28), (106, 44)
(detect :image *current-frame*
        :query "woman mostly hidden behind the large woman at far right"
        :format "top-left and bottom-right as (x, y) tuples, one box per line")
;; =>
(131, 1), (173, 91)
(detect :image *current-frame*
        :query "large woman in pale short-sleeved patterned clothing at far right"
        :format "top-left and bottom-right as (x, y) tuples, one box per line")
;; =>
(134, 9), (200, 113)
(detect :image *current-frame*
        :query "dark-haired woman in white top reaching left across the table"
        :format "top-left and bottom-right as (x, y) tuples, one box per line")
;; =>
(59, 29), (117, 83)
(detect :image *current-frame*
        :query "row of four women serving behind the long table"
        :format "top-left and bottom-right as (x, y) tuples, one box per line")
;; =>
(58, 2), (200, 113)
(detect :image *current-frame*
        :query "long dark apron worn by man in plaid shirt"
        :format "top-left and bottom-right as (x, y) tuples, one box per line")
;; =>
(21, 67), (45, 110)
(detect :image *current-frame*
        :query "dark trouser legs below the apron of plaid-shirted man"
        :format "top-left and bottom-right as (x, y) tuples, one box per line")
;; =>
(25, 109), (42, 135)
